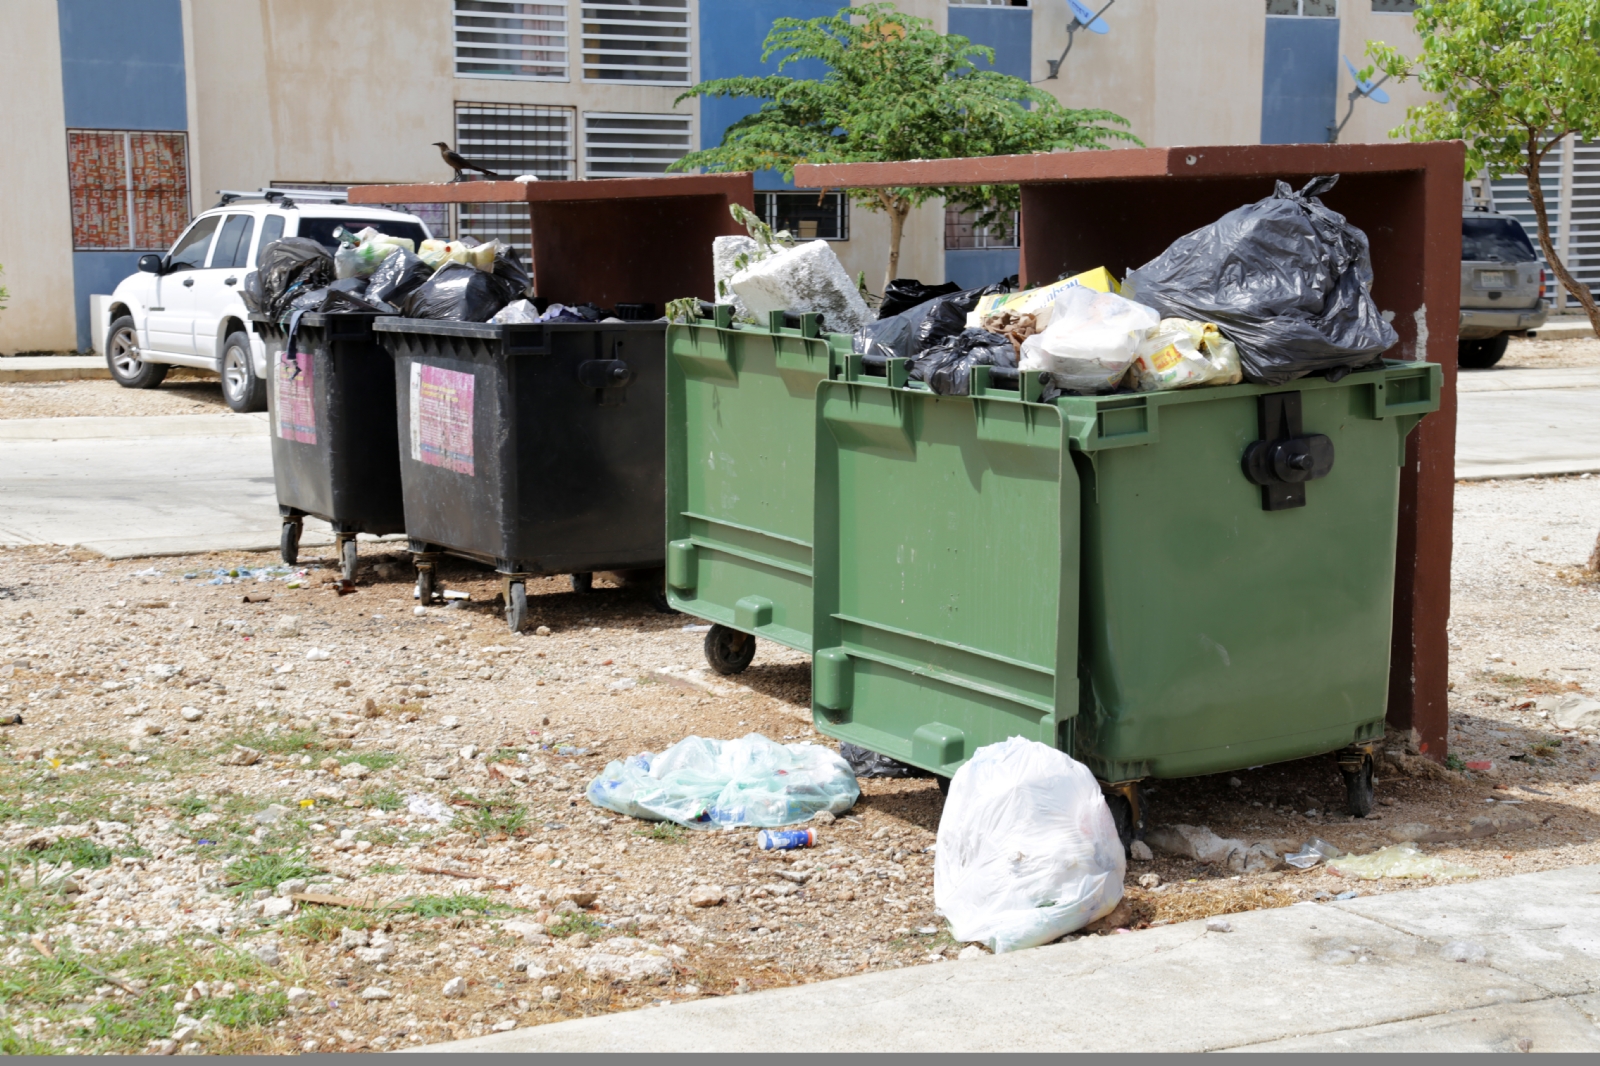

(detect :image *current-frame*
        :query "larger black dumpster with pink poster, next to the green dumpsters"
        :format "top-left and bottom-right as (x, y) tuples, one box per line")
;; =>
(374, 319), (667, 631)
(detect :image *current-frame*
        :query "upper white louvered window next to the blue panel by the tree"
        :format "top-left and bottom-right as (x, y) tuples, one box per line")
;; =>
(582, 0), (690, 85)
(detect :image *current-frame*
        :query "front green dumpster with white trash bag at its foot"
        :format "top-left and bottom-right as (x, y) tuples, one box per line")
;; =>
(813, 357), (1442, 839)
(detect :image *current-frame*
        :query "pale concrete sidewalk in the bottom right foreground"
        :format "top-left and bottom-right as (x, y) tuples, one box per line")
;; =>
(411, 866), (1600, 1053)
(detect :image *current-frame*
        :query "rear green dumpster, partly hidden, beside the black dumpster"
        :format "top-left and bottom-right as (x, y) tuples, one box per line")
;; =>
(667, 304), (850, 674)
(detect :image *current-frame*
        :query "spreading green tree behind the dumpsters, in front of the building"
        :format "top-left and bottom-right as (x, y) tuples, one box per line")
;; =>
(674, 3), (1139, 283)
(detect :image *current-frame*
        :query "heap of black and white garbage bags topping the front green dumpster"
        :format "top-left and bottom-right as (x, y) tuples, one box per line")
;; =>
(806, 174), (1398, 399)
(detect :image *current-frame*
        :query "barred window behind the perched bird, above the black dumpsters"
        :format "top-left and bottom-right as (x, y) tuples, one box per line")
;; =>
(456, 102), (574, 246)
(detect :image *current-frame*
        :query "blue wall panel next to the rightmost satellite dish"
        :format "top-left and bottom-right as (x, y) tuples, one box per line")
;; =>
(1261, 18), (1339, 144)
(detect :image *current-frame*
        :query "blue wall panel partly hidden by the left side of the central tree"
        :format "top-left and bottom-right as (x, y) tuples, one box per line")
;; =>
(699, 0), (845, 189)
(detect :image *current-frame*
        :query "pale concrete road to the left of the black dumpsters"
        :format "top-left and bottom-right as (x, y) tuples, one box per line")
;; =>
(0, 415), (333, 559)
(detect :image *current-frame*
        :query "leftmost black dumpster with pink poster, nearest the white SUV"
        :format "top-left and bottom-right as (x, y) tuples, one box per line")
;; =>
(250, 314), (405, 579)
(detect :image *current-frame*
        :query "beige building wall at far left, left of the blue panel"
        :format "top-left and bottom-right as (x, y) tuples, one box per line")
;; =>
(0, 0), (77, 354)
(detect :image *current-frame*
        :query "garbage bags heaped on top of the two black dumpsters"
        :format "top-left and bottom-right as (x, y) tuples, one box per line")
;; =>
(243, 226), (533, 322)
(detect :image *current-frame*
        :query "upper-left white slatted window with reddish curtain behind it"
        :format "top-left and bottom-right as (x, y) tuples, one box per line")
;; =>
(456, 0), (570, 82)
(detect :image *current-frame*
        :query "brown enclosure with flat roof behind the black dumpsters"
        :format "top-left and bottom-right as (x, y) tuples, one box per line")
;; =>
(349, 173), (755, 311)
